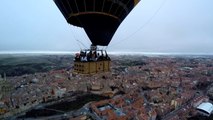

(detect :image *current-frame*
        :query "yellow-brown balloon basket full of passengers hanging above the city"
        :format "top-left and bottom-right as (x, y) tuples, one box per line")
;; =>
(73, 49), (111, 74)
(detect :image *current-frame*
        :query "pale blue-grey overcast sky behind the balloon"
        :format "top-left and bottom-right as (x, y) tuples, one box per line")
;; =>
(0, 0), (213, 54)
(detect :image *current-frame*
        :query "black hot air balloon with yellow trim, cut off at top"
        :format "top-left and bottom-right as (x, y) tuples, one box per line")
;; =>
(54, 0), (140, 73)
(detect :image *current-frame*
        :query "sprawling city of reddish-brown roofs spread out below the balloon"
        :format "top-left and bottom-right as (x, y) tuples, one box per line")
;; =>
(0, 55), (213, 120)
